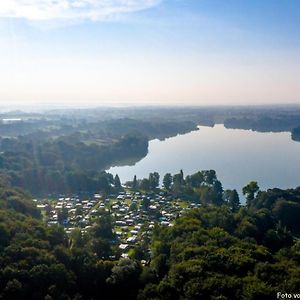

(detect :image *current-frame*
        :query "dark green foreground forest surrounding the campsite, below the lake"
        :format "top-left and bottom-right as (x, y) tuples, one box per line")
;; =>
(0, 170), (300, 300)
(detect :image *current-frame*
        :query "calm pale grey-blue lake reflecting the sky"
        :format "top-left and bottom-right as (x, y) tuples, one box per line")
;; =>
(108, 125), (300, 192)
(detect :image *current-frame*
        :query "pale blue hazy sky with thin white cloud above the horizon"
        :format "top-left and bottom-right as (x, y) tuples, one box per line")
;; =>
(0, 0), (300, 105)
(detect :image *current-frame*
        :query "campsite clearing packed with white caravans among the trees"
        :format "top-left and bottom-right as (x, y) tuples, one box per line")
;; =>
(34, 190), (200, 257)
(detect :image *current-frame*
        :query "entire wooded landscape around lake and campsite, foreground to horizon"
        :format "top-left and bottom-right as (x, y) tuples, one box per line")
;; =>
(0, 107), (300, 300)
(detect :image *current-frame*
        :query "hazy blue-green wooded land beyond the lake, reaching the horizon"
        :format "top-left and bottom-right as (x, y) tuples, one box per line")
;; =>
(0, 107), (300, 195)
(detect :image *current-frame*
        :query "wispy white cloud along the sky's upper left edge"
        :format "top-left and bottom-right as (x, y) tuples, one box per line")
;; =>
(0, 0), (161, 21)
